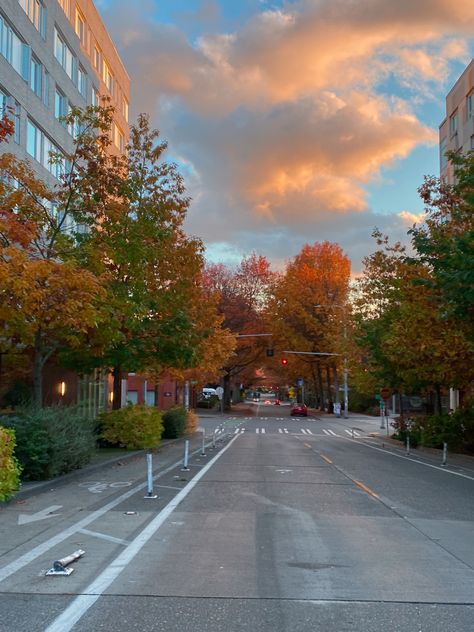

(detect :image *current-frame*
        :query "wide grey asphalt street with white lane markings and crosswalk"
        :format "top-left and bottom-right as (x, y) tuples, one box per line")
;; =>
(0, 404), (474, 632)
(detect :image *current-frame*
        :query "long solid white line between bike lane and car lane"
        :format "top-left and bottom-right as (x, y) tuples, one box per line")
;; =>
(45, 437), (241, 632)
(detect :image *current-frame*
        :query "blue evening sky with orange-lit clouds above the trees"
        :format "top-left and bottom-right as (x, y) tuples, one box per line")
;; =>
(96, 0), (474, 274)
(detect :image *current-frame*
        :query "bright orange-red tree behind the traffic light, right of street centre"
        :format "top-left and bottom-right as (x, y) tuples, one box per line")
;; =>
(267, 242), (350, 405)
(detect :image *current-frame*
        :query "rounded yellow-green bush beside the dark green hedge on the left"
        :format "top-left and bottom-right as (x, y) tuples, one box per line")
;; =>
(99, 404), (163, 450)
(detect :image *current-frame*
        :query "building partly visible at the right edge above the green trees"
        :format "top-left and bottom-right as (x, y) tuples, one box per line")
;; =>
(439, 59), (474, 183)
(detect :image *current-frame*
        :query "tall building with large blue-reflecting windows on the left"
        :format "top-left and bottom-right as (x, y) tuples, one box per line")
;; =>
(0, 0), (130, 181)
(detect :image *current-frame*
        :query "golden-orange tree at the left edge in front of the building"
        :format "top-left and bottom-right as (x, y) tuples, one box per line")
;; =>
(0, 110), (106, 405)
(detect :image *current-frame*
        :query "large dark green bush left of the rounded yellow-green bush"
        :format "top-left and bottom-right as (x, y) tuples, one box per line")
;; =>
(3, 406), (96, 480)
